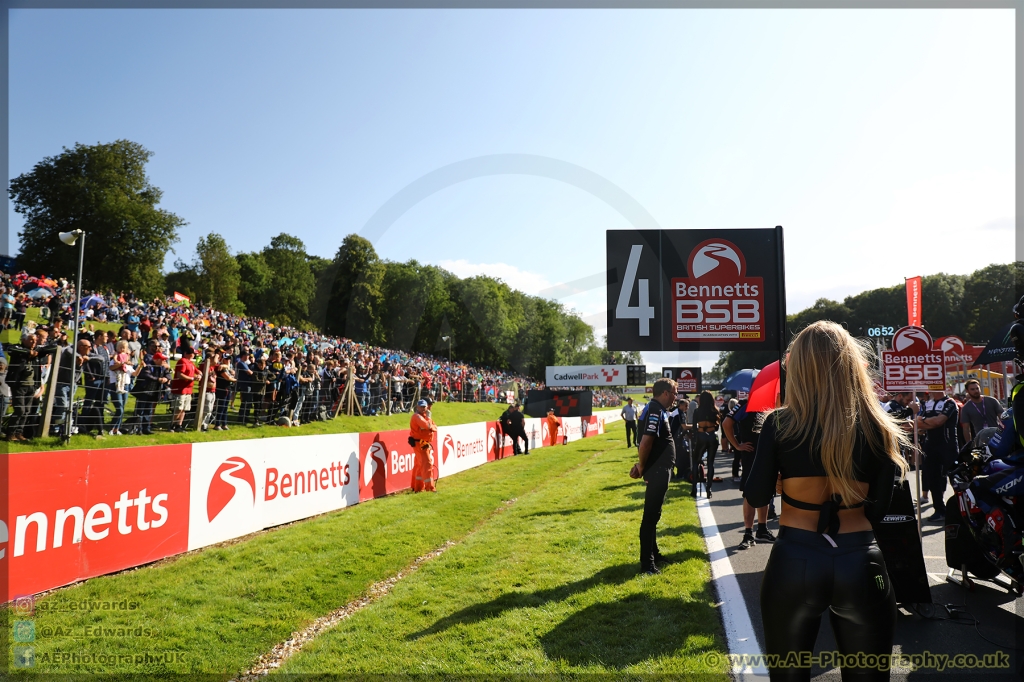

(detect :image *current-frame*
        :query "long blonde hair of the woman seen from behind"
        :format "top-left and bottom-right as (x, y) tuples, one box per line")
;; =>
(776, 321), (908, 505)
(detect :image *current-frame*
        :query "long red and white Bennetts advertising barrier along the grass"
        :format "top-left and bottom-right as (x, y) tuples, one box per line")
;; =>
(0, 405), (618, 603)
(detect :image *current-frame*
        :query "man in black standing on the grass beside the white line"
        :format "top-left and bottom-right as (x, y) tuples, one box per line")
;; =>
(630, 379), (676, 576)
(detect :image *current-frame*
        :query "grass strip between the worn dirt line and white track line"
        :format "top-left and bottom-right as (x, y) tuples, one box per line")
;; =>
(279, 428), (725, 678)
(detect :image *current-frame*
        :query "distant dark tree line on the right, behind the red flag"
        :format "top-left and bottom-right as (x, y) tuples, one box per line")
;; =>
(710, 261), (1024, 380)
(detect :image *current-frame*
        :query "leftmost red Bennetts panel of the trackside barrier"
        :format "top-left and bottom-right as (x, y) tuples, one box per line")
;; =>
(0, 443), (191, 601)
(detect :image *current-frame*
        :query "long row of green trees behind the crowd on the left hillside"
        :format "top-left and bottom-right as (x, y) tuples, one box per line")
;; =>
(9, 140), (640, 377)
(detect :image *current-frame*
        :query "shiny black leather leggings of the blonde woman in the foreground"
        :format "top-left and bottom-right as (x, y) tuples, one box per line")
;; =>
(761, 526), (896, 682)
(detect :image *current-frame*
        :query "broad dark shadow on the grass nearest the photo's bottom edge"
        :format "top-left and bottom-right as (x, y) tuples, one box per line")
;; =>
(541, 594), (718, 669)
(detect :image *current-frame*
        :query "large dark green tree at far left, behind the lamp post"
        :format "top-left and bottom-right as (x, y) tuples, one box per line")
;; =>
(8, 139), (185, 297)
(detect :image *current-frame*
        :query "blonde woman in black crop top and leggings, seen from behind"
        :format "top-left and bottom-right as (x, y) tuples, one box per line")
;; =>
(743, 322), (906, 680)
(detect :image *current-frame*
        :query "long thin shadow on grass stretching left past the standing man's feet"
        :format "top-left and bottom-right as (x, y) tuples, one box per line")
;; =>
(406, 550), (707, 641)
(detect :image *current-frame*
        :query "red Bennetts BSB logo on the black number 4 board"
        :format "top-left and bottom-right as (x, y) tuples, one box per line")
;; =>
(672, 239), (765, 341)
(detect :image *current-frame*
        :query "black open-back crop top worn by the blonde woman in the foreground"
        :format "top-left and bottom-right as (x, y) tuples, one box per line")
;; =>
(743, 413), (896, 532)
